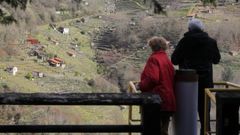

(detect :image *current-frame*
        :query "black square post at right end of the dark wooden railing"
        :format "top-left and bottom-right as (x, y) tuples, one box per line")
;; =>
(141, 104), (161, 135)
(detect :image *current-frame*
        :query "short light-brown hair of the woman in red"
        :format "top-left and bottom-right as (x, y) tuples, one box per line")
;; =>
(148, 36), (169, 52)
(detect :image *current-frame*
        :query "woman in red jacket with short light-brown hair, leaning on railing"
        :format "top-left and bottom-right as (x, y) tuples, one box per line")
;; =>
(139, 37), (176, 135)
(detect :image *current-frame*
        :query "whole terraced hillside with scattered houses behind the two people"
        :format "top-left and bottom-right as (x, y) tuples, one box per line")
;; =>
(0, 0), (240, 134)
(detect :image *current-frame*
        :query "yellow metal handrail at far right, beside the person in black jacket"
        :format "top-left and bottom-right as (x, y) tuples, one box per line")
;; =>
(204, 82), (240, 135)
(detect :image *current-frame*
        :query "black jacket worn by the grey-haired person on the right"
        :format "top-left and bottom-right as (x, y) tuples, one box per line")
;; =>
(171, 30), (221, 89)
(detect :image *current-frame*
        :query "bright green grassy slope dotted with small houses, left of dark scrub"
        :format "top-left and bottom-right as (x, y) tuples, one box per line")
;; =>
(0, 0), (126, 132)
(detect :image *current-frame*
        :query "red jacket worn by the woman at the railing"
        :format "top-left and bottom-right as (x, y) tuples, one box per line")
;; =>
(139, 51), (176, 112)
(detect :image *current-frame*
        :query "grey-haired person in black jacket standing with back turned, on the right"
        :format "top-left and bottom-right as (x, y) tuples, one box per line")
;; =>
(171, 19), (221, 135)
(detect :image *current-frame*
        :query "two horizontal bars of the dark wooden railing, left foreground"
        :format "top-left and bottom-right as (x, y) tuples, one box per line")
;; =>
(0, 93), (161, 135)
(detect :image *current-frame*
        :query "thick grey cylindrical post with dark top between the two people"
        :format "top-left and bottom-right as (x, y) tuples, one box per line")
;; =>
(174, 69), (198, 135)
